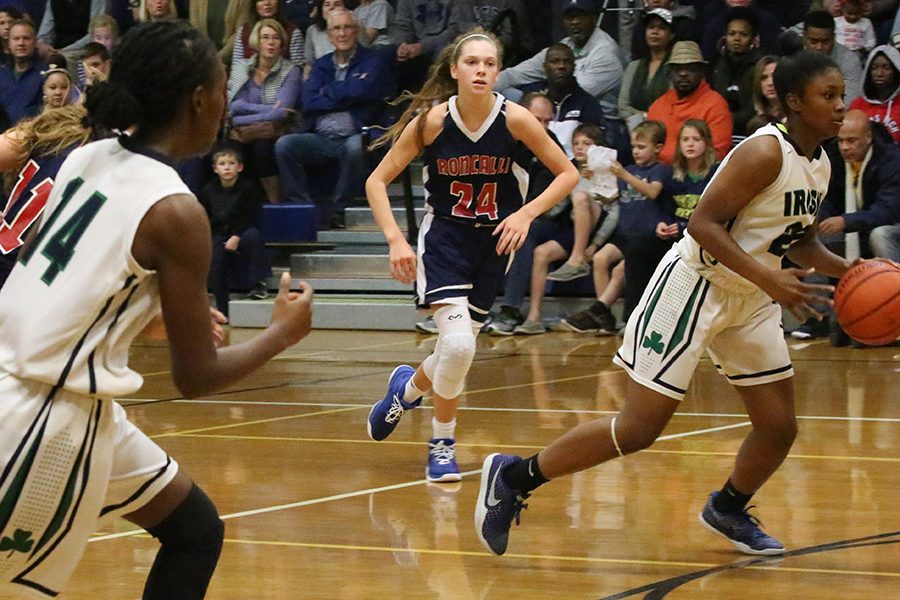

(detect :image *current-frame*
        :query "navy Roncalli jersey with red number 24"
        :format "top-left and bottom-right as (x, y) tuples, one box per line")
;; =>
(423, 94), (528, 225)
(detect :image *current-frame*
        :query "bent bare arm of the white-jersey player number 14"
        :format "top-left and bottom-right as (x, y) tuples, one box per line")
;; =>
(132, 195), (312, 397)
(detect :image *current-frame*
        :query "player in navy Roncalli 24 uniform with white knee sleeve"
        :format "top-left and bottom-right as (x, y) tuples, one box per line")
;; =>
(366, 29), (578, 482)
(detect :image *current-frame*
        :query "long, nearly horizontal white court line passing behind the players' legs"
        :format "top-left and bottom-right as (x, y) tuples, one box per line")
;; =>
(120, 398), (900, 423)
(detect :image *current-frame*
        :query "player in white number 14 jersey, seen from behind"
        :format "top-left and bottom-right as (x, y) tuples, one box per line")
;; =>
(0, 21), (311, 600)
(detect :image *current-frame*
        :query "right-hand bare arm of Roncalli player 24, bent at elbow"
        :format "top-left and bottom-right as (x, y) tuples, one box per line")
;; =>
(502, 102), (579, 254)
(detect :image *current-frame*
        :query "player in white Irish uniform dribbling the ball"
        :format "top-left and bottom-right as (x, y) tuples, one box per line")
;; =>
(475, 52), (849, 555)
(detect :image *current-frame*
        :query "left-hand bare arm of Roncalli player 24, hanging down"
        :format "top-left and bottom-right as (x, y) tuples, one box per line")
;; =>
(366, 107), (443, 283)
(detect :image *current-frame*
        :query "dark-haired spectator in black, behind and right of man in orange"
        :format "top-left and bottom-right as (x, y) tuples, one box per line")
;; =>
(711, 6), (759, 138)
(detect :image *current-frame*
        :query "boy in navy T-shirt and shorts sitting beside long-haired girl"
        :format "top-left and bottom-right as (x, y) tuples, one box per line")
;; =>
(562, 121), (667, 335)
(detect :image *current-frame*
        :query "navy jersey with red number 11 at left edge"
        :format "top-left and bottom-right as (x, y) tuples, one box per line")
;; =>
(0, 144), (77, 287)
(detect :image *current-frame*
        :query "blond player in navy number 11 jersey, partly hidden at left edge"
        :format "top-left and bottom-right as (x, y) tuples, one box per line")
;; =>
(0, 105), (91, 288)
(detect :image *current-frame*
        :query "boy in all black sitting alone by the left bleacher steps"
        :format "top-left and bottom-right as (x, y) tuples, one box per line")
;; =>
(199, 147), (271, 316)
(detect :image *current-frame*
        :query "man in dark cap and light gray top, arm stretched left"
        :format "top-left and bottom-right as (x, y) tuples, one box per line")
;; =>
(494, 0), (622, 117)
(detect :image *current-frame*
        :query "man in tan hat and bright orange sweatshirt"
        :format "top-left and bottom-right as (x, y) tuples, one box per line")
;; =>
(647, 42), (732, 165)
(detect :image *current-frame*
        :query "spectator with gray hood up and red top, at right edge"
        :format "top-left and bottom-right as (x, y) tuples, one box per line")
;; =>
(850, 44), (900, 143)
